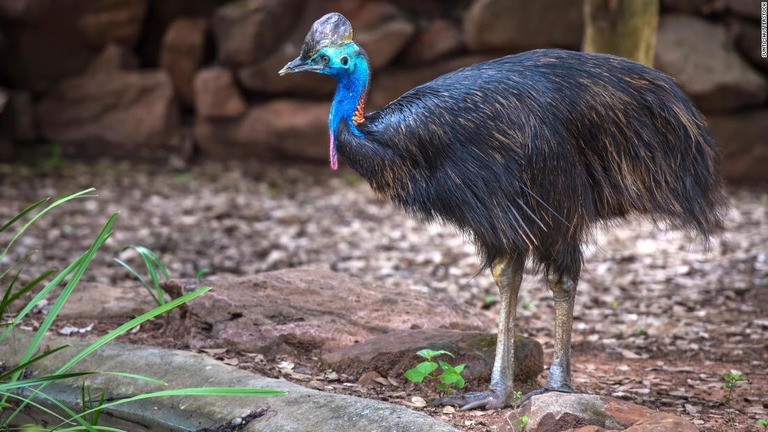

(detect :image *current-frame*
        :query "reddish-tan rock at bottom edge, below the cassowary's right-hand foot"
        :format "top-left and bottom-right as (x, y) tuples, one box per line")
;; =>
(507, 393), (697, 432)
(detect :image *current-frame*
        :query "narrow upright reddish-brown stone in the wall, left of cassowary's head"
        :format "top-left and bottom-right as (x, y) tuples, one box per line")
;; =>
(160, 18), (208, 106)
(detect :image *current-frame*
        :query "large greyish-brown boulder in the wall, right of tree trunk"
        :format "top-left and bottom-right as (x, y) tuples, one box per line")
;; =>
(656, 15), (768, 111)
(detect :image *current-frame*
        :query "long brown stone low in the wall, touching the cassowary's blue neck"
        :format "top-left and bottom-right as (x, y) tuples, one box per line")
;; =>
(195, 99), (330, 161)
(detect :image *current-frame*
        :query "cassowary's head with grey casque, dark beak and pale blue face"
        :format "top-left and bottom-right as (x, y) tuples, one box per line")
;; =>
(279, 12), (367, 79)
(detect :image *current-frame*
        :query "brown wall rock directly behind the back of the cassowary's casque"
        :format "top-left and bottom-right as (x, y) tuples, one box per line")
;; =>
(348, 1), (416, 70)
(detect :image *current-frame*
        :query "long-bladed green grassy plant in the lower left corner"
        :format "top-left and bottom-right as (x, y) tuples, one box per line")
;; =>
(0, 189), (284, 431)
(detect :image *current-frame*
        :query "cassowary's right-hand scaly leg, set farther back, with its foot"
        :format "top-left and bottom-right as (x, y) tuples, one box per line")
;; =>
(519, 268), (578, 405)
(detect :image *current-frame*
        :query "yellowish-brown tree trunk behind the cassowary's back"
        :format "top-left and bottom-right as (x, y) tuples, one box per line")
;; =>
(582, 0), (659, 66)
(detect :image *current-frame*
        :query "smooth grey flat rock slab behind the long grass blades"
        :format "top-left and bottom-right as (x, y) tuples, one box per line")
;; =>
(0, 330), (456, 432)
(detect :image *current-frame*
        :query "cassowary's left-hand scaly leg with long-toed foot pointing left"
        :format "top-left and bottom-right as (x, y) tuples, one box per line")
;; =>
(430, 257), (525, 410)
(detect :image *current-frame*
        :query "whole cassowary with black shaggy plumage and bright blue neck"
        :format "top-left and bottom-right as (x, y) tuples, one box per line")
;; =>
(280, 13), (725, 409)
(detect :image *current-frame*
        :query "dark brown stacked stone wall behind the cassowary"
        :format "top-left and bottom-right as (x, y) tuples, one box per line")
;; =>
(0, 0), (768, 181)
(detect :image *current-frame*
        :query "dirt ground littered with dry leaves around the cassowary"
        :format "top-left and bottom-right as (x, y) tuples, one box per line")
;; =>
(0, 161), (768, 431)
